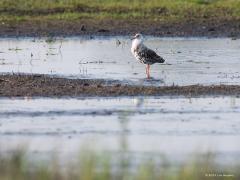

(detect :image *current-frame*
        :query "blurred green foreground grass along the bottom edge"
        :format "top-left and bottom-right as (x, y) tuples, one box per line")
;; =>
(0, 151), (240, 180)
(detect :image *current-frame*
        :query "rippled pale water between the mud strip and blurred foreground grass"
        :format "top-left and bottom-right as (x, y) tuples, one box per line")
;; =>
(0, 97), (240, 163)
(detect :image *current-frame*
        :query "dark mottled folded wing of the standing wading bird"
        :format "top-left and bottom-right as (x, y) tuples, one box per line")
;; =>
(138, 47), (165, 63)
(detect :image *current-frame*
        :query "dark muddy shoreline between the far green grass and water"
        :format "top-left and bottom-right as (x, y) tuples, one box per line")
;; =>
(0, 18), (240, 38)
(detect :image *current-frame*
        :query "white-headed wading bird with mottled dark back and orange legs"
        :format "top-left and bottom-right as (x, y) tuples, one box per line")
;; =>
(131, 34), (165, 79)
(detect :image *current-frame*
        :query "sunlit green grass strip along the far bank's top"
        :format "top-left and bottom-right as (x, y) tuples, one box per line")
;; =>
(0, 0), (240, 21)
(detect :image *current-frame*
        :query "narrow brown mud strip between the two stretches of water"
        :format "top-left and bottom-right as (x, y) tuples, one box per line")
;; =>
(0, 75), (240, 97)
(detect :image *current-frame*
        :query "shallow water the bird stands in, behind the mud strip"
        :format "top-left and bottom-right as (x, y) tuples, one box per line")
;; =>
(0, 37), (240, 86)
